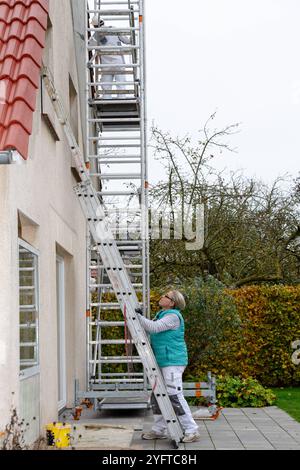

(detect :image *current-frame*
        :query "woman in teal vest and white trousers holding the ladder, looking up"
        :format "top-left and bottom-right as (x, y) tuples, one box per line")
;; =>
(140, 290), (200, 442)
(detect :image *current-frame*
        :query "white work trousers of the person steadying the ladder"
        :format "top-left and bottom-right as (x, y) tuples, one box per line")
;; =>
(152, 366), (198, 434)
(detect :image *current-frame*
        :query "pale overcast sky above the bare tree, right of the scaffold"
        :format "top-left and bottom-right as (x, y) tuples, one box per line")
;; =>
(146, 0), (300, 184)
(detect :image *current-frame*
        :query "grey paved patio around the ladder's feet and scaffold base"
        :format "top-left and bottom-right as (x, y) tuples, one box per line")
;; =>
(62, 406), (300, 450)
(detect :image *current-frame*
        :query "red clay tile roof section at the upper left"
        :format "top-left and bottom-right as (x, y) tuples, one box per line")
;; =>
(0, 0), (49, 160)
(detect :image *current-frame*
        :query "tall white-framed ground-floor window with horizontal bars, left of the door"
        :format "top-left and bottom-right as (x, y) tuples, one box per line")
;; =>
(19, 240), (39, 377)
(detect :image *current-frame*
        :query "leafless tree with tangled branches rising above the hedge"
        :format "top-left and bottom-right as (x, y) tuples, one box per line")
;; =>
(150, 119), (300, 286)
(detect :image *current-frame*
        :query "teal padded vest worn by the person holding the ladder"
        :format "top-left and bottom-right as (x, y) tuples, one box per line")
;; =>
(150, 309), (188, 367)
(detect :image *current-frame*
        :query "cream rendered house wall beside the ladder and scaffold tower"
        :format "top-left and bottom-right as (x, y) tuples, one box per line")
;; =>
(0, 0), (86, 442)
